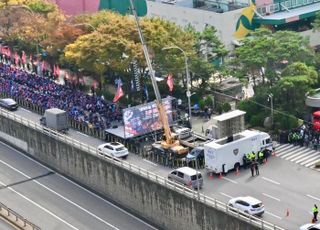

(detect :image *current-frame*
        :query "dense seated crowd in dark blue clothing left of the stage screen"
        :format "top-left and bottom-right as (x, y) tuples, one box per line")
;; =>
(0, 64), (122, 130)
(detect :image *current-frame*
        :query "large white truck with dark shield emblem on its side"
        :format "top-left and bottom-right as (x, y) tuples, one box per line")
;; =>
(204, 130), (273, 174)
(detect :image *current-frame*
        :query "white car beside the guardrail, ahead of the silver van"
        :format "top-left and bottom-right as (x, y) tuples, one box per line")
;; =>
(228, 196), (264, 216)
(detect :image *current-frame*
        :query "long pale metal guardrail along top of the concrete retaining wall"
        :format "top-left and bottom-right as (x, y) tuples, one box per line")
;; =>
(0, 109), (284, 230)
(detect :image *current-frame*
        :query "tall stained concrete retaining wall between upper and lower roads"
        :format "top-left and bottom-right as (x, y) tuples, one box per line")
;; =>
(0, 116), (260, 230)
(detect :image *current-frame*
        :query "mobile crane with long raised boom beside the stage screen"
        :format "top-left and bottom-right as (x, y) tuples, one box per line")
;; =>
(129, 0), (188, 154)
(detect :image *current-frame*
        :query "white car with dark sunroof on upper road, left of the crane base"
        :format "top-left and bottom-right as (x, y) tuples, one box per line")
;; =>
(98, 142), (129, 159)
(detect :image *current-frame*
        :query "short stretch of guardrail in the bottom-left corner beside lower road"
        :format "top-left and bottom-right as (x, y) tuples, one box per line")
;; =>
(0, 202), (41, 230)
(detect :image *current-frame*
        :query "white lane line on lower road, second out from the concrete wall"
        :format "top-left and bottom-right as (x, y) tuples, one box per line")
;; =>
(0, 160), (119, 230)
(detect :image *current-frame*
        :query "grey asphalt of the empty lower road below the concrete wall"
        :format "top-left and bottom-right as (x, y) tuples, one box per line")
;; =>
(0, 139), (156, 230)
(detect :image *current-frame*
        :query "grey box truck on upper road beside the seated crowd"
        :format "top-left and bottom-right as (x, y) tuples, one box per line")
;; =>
(40, 108), (68, 133)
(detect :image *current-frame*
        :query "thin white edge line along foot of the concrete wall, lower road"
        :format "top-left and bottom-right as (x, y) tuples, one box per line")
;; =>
(0, 141), (158, 230)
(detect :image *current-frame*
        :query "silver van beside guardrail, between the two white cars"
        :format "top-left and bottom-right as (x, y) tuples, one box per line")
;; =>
(168, 167), (203, 189)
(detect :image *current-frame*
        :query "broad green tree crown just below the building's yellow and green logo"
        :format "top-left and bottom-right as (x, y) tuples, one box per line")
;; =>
(232, 29), (314, 84)
